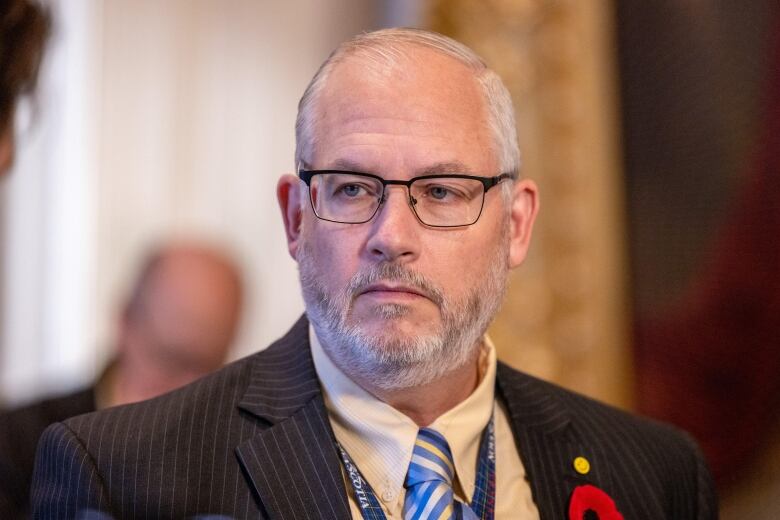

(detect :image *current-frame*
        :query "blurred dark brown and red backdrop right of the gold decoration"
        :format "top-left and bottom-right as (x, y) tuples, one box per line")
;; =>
(617, 0), (780, 490)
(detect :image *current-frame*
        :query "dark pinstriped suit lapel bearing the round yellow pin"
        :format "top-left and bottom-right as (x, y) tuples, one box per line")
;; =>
(498, 363), (611, 519)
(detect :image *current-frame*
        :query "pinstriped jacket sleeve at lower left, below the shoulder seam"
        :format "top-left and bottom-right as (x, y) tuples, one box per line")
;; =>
(30, 423), (110, 519)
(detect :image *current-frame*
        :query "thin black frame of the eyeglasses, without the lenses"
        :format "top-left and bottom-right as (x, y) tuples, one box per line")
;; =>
(298, 169), (516, 228)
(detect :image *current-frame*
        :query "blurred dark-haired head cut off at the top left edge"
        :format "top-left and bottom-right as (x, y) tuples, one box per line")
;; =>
(0, 0), (49, 176)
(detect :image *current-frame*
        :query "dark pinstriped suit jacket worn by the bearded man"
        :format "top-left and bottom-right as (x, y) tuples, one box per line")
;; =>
(32, 317), (717, 520)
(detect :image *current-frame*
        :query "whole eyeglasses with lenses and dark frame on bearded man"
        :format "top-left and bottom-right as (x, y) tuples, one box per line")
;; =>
(298, 169), (514, 227)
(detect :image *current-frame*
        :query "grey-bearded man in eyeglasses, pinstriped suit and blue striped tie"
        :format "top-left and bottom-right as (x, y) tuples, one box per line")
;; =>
(33, 29), (716, 519)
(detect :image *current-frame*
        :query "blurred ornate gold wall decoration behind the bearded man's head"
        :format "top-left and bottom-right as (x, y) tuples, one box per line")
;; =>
(429, 0), (632, 407)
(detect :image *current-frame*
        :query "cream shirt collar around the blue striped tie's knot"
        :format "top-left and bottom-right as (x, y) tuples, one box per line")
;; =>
(309, 326), (496, 509)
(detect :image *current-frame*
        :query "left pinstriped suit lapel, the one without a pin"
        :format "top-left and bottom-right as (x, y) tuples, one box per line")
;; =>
(236, 317), (350, 520)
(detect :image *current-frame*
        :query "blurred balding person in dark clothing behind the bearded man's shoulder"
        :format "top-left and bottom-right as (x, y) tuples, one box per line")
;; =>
(0, 244), (242, 519)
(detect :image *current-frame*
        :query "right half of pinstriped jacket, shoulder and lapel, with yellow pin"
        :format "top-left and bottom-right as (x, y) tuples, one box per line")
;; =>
(498, 364), (717, 519)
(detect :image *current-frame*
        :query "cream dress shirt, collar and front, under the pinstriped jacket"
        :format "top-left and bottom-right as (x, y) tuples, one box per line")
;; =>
(309, 326), (539, 520)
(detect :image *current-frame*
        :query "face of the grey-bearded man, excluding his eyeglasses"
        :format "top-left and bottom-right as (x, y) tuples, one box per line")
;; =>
(284, 49), (536, 387)
